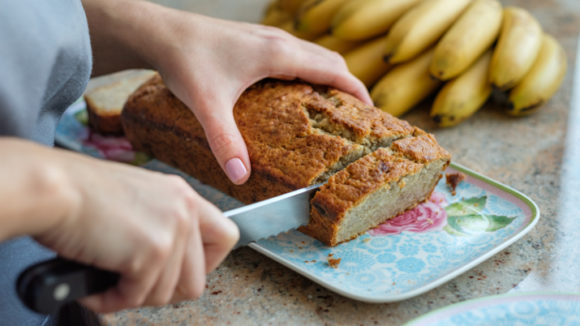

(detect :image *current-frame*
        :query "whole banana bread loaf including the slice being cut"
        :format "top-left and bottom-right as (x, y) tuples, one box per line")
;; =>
(122, 76), (450, 245)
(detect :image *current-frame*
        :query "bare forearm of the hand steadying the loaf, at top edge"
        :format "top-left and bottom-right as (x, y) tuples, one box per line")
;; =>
(83, 0), (173, 76)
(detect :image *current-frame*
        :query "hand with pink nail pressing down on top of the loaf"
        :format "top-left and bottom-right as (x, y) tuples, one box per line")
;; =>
(144, 10), (372, 184)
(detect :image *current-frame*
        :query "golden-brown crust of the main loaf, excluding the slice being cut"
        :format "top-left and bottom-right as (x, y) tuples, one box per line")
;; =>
(122, 75), (413, 203)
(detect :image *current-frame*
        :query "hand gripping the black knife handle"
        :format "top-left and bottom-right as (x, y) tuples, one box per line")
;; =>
(26, 146), (239, 312)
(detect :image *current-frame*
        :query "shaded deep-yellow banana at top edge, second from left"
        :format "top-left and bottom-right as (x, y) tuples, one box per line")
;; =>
(296, 0), (348, 39)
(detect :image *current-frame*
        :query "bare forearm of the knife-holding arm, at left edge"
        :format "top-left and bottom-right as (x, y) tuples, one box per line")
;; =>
(0, 137), (76, 241)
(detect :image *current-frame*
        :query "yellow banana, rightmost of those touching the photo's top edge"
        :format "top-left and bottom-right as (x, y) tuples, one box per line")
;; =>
(430, 0), (503, 80)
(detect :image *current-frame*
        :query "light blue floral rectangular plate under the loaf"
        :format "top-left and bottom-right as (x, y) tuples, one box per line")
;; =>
(56, 101), (539, 303)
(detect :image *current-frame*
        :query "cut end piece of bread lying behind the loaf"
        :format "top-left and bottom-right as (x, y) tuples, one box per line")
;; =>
(84, 71), (155, 135)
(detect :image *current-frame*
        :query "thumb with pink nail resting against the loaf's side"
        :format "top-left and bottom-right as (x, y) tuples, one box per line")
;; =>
(197, 103), (251, 185)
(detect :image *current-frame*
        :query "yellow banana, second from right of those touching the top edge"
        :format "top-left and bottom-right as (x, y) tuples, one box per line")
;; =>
(385, 0), (470, 63)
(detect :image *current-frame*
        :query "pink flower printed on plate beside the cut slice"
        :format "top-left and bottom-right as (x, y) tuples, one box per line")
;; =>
(369, 191), (447, 236)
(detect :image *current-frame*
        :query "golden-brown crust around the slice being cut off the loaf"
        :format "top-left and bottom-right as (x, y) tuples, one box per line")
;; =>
(300, 134), (451, 246)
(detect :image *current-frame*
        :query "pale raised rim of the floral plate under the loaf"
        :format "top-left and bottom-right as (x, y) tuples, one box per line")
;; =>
(248, 162), (540, 304)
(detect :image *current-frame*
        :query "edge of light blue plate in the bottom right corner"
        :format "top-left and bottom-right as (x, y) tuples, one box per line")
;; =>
(405, 293), (580, 326)
